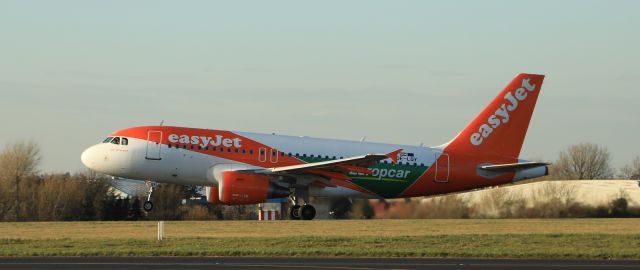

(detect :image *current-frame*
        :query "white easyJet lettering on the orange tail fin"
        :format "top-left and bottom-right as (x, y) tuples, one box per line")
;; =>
(469, 79), (536, 145)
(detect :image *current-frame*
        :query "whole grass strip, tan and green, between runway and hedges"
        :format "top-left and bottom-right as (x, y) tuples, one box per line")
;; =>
(0, 219), (640, 259)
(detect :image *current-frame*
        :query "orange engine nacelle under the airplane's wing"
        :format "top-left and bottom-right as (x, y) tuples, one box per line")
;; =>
(220, 171), (289, 204)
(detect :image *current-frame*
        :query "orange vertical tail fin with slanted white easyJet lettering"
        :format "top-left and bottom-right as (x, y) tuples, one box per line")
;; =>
(445, 73), (544, 159)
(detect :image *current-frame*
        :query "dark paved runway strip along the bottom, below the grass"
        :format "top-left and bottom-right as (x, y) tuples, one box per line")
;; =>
(0, 257), (640, 270)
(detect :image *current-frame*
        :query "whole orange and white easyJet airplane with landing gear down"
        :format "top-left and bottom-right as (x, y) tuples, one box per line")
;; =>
(81, 73), (548, 220)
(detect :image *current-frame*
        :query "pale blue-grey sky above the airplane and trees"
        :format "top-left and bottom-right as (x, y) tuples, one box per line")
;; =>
(0, 1), (640, 172)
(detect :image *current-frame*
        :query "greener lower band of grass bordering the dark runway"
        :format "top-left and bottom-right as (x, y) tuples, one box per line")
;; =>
(0, 234), (640, 259)
